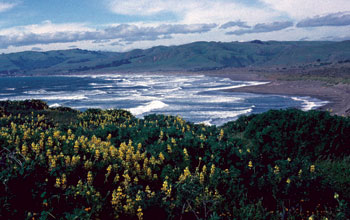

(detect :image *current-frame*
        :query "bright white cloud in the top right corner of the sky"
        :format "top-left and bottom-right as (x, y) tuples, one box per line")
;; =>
(261, 0), (350, 20)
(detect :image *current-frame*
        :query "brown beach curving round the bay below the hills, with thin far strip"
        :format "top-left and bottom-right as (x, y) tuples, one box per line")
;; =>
(2, 68), (350, 116)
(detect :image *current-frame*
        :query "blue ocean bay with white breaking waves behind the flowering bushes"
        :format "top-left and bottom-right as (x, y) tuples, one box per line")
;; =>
(0, 74), (327, 126)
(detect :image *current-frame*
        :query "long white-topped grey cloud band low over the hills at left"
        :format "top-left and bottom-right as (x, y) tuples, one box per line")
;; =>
(0, 21), (217, 49)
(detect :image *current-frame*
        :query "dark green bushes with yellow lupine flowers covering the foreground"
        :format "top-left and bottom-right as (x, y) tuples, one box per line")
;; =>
(0, 100), (350, 219)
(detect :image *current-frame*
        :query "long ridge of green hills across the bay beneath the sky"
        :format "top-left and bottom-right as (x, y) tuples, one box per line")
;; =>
(0, 40), (350, 75)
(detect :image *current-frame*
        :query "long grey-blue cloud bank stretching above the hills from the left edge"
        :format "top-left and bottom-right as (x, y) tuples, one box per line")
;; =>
(0, 24), (217, 49)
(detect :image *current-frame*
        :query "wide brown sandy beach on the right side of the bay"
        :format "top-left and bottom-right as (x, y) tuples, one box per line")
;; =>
(203, 70), (350, 116)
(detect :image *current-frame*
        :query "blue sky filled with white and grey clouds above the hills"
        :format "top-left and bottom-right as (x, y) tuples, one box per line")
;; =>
(0, 0), (350, 53)
